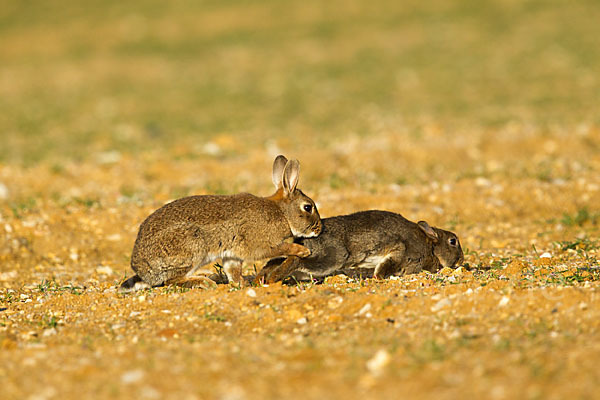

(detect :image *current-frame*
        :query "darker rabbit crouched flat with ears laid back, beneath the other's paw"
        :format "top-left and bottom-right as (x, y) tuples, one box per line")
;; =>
(255, 210), (464, 283)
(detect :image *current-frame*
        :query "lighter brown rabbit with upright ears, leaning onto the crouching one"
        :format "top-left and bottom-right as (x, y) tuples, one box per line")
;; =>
(120, 155), (322, 292)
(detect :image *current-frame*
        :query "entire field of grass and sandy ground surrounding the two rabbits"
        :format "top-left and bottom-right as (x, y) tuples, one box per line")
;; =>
(0, 1), (600, 400)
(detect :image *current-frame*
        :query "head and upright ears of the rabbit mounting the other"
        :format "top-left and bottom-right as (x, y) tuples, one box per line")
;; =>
(271, 155), (323, 238)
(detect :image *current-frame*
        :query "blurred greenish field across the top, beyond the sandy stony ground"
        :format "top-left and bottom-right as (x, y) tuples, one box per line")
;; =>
(0, 0), (600, 166)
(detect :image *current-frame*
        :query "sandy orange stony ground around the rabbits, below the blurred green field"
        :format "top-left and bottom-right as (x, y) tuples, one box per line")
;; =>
(0, 130), (600, 399)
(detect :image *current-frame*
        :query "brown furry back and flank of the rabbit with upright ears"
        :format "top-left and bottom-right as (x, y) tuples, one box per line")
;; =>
(132, 193), (291, 264)
